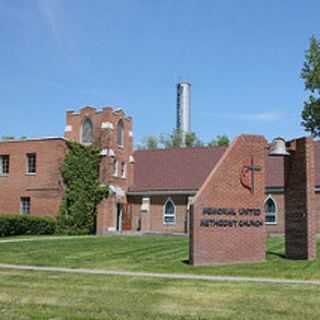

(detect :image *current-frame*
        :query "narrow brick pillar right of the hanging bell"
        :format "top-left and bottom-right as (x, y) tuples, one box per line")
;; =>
(285, 138), (317, 260)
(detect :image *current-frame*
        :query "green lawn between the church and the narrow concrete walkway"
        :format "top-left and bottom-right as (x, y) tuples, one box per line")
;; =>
(0, 235), (320, 280)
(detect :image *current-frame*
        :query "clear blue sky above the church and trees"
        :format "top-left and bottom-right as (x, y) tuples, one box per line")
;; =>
(0, 0), (320, 143)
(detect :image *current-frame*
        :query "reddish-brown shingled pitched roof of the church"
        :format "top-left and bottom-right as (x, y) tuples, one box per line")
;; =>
(129, 142), (320, 192)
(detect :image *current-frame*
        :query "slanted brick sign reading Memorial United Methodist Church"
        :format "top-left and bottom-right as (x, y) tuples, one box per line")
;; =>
(190, 135), (267, 265)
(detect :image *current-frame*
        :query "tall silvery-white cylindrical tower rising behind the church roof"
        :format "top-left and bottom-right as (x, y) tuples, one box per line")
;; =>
(177, 81), (191, 133)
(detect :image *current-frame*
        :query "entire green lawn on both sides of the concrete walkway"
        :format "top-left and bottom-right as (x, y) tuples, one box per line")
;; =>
(0, 236), (320, 320)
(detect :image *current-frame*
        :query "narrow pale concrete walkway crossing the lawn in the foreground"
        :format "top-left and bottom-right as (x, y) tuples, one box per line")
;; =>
(0, 263), (320, 286)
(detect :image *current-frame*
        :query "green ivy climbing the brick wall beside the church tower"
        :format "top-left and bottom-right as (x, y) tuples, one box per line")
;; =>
(58, 142), (109, 234)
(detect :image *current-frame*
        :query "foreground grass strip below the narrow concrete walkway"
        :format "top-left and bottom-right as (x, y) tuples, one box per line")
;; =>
(0, 270), (320, 320)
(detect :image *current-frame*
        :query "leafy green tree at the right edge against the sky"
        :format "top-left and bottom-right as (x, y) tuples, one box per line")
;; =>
(301, 36), (320, 137)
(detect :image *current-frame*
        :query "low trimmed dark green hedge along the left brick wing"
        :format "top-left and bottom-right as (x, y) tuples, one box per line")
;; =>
(0, 214), (56, 237)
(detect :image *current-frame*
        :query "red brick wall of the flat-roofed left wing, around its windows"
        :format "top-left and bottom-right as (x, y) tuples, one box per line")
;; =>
(0, 139), (67, 216)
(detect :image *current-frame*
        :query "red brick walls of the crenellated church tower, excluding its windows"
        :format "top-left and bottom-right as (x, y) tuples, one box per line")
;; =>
(65, 107), (133, 234)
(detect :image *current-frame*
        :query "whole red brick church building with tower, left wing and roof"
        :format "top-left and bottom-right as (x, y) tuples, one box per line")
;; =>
(0, 107), (320, 234)
